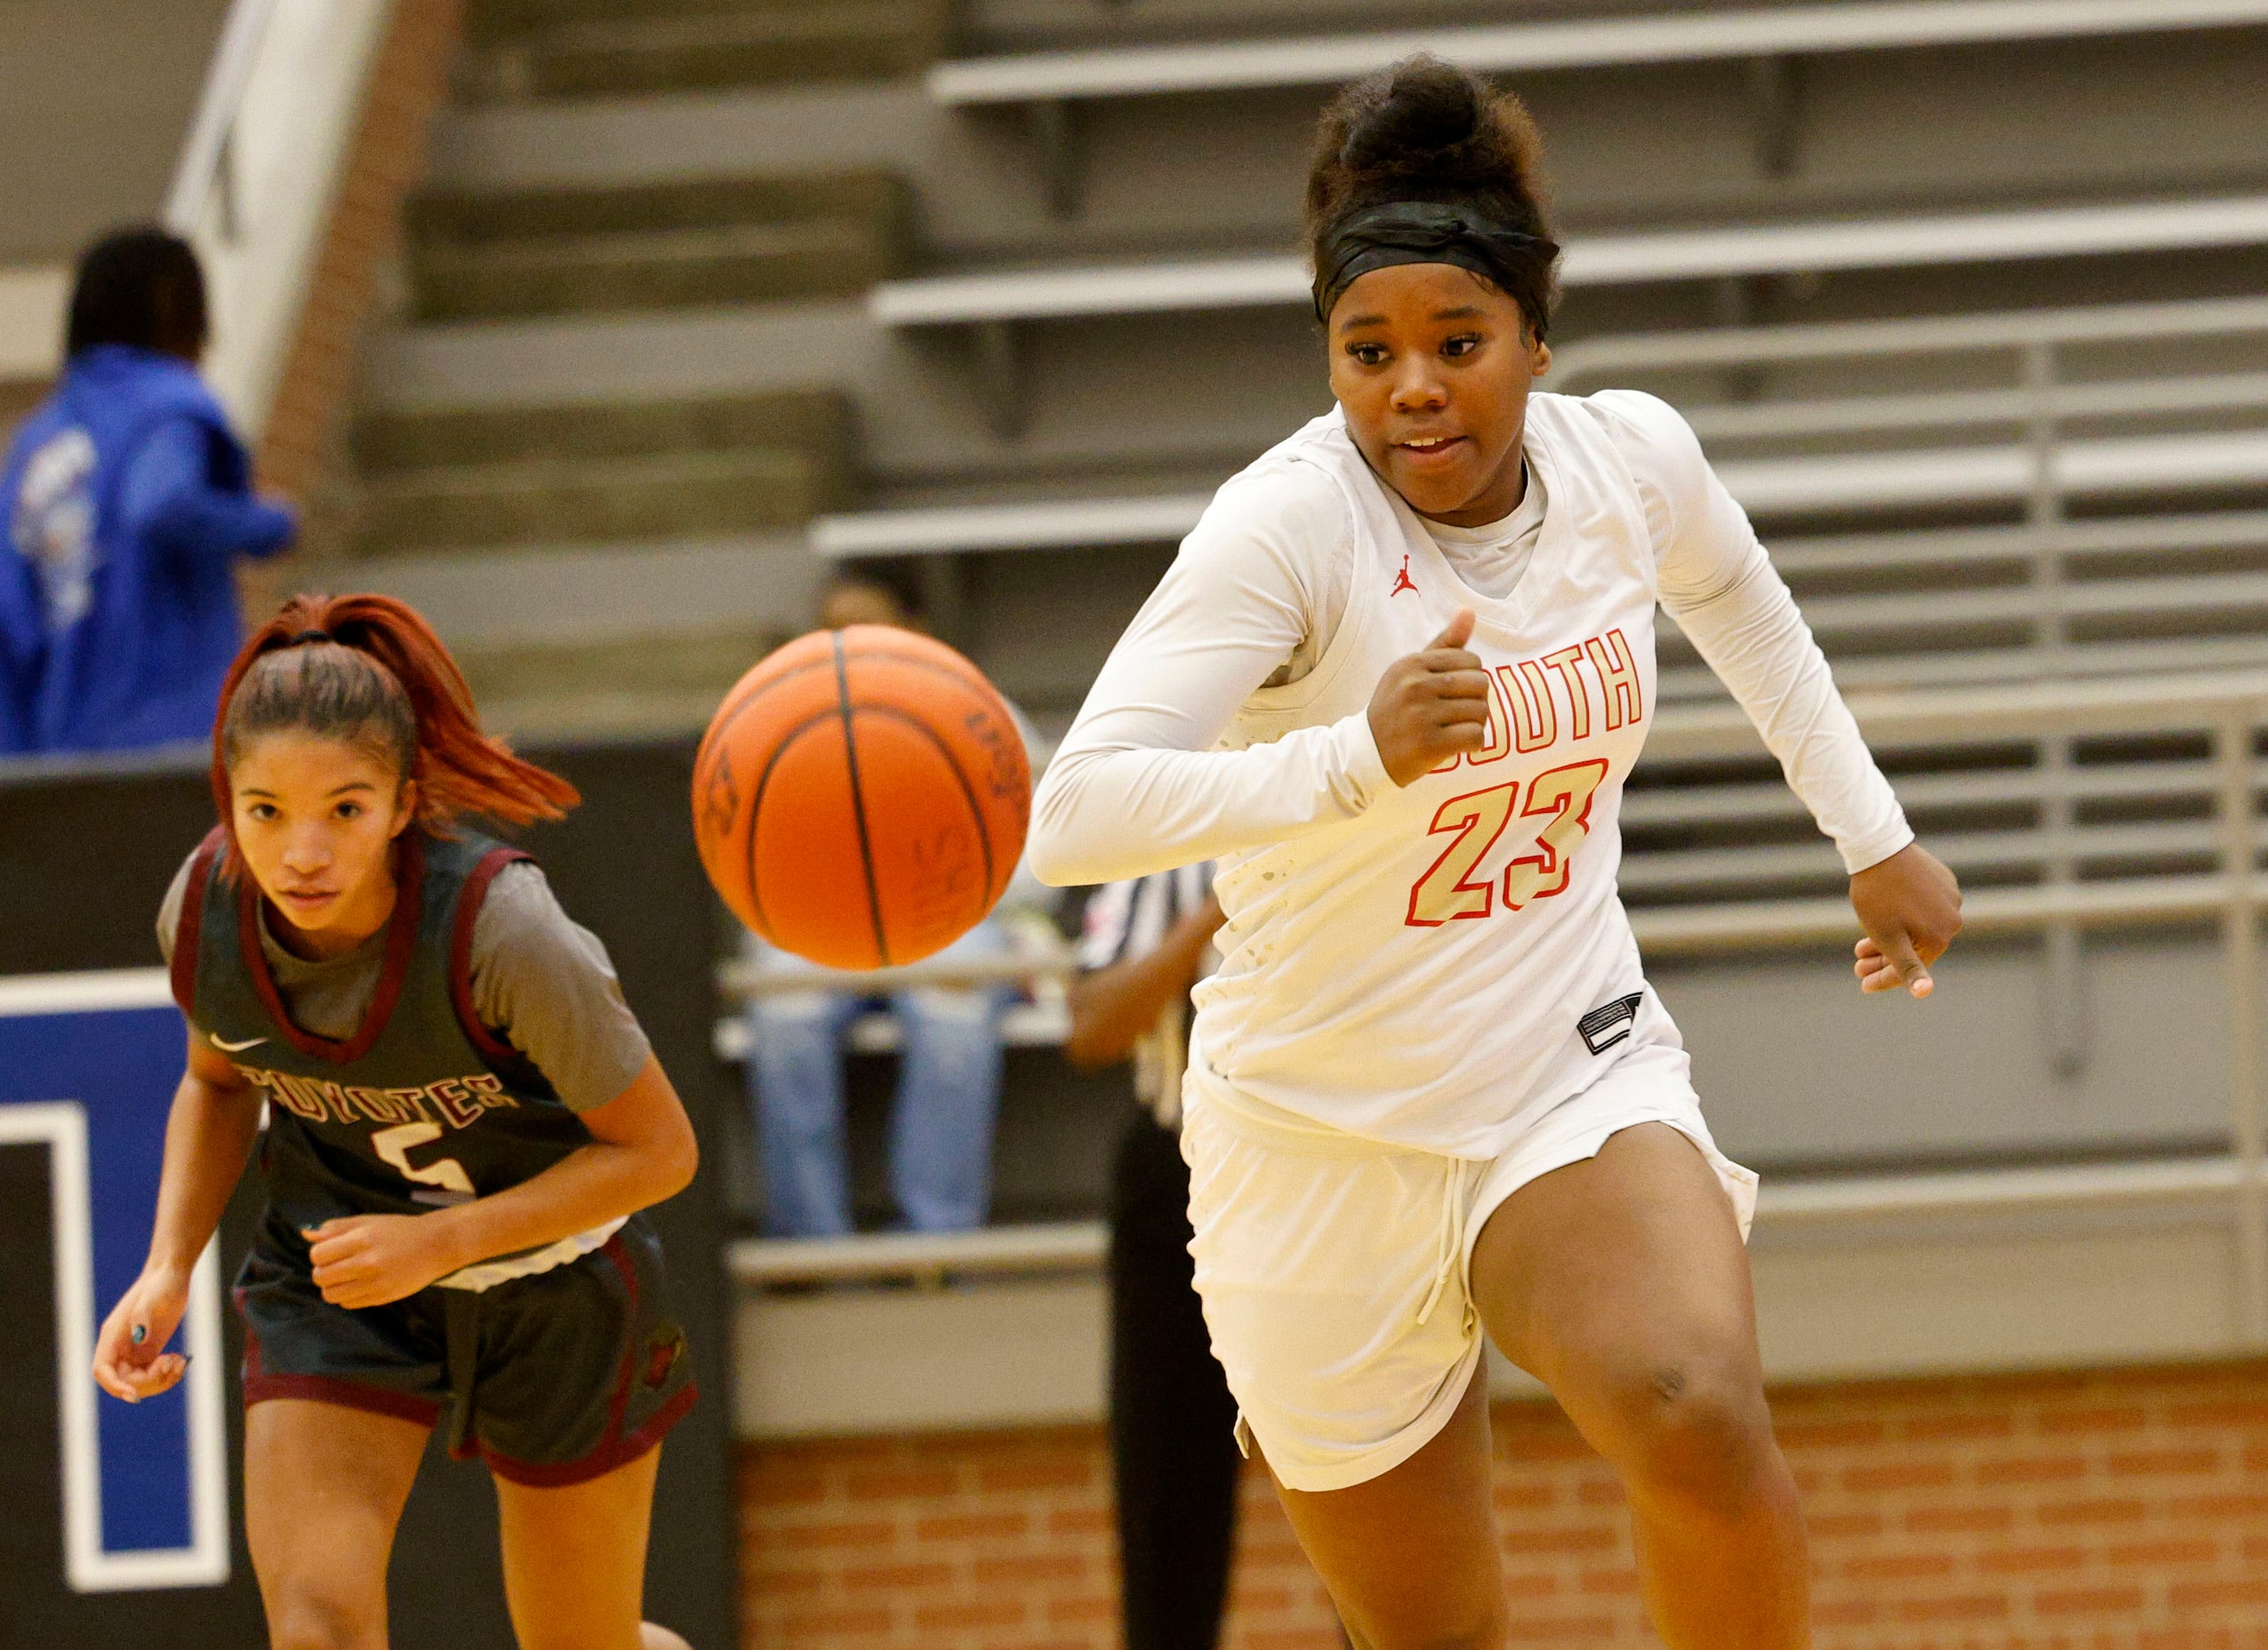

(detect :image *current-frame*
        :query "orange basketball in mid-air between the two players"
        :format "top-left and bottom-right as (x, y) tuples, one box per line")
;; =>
(694, 624), (1032, 969)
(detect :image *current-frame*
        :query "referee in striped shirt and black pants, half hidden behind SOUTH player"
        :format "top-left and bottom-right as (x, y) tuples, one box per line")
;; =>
(1064, 865), (1239, 1650)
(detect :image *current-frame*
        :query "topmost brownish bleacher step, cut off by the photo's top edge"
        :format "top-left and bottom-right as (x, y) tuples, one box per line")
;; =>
(465, 0), (946, 102)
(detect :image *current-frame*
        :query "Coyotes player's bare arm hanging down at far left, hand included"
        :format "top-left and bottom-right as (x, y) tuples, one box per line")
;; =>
(95, 1026), (261, 1402)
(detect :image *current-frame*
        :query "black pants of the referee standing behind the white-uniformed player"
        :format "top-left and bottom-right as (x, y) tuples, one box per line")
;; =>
(1111, 1112), (1239, 1650)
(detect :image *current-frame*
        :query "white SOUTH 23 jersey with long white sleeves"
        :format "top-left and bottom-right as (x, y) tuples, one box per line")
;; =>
(1032, 394), (1912, 1157)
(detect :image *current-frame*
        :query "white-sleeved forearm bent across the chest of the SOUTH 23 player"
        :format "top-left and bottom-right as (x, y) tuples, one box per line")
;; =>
(1028, 715), (1392, 887)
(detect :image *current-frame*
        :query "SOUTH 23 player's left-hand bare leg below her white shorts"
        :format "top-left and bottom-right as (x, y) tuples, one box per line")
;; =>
(1277, 1366), (1508, 1650)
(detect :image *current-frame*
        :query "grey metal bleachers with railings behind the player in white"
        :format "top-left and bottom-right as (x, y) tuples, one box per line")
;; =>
(655, 0), (2268, 1435)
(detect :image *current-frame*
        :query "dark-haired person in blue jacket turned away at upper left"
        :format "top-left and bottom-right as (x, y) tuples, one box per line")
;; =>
(0, 229), (295, 751)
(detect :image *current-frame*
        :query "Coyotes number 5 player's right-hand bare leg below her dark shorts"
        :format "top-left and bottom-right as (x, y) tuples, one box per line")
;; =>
(496, 1448), (662, 1650)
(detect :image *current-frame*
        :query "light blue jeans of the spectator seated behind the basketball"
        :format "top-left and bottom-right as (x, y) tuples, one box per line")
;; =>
(748, 922), (1014, 1237)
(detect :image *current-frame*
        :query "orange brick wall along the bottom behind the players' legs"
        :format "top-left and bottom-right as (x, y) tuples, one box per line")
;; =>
(740, 1364), (2268, 1650)
